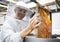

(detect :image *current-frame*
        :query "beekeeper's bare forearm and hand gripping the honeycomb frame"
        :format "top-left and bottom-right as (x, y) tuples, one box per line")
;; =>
(20, 15), (40, 38)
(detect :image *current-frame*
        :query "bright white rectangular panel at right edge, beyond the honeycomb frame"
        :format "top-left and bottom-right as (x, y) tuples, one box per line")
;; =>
(52, 13), (60, 34)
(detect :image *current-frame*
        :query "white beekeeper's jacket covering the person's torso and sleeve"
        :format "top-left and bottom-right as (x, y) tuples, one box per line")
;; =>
(2, 17), (28, 42)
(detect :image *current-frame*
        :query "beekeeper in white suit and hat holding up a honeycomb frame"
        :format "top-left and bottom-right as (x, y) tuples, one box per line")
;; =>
(2, 1), (40, 42)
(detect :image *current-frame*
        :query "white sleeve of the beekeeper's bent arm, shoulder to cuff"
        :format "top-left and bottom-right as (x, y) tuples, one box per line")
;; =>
(2, 21), (23, 42)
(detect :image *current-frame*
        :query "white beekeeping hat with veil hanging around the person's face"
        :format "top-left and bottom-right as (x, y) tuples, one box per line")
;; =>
(6, 1), (36, 20)
